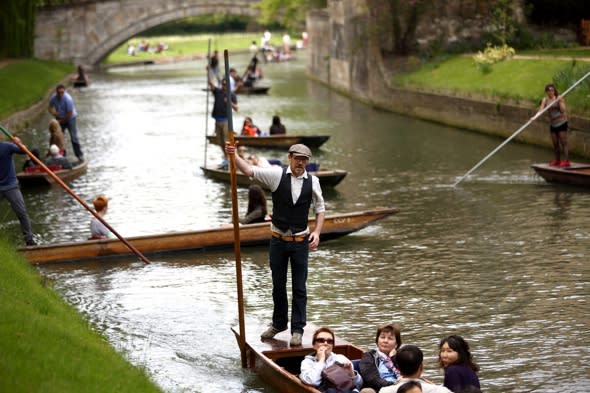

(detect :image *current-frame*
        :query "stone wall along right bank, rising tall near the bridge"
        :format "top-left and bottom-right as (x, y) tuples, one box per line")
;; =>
(307, 0), (590, 157)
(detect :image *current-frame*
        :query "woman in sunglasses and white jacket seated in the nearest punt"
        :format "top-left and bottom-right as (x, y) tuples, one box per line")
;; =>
(299, 327), (363, 393)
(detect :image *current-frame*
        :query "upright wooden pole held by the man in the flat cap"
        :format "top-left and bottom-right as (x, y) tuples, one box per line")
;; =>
(223, 49), (248, 368)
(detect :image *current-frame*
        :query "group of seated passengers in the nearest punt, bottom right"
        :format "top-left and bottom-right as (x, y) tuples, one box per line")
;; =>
(299, 323), (481, 393)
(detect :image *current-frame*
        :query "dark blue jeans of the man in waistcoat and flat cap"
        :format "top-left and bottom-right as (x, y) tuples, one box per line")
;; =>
(269, 237), (309, 333)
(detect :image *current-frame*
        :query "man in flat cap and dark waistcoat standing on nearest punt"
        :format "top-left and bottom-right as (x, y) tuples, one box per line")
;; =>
(225, 143), (326, 346)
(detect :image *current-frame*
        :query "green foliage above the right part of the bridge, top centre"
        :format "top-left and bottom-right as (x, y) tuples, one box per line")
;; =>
(254, 0), (327, 33)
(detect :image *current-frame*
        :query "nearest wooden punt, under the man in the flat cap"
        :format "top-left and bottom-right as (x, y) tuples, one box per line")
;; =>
(232, 320), (364, 393)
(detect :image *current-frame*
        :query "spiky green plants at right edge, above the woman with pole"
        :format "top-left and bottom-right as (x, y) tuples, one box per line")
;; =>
(553, 60), (590, 111)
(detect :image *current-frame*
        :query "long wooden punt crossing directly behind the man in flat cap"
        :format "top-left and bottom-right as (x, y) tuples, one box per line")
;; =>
(18, 208), (399, 264)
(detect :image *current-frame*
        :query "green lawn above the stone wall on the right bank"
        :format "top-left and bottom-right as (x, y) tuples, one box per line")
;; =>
(392, 56), (590, 115)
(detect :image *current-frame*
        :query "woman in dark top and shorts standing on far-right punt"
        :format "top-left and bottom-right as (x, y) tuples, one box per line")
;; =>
(537, 83), (570, 168)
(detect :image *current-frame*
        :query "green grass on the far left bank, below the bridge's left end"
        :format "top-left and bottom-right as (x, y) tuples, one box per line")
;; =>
(0, 59), (76, 119)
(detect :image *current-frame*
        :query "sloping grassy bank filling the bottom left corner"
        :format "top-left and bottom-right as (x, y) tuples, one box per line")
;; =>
(0, 239), (160, 393)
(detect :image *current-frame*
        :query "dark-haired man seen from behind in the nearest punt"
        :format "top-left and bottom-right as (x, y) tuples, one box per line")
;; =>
(379, 344), (452, 393)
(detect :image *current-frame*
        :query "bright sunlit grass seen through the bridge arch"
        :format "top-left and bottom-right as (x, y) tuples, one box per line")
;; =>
(104, 33), (261, 64)
